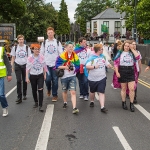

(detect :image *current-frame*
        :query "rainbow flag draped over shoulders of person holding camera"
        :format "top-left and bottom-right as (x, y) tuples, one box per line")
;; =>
(54, 52), (80, 72)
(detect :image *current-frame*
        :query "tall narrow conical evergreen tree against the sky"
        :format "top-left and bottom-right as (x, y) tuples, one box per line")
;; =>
(57, 0), (70, 35)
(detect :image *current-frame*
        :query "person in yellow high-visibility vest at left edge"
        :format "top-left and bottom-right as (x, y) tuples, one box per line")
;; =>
(0, 47), (12, 117)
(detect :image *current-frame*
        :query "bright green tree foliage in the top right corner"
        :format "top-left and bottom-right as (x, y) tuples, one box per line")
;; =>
(115, 0), (150, 39)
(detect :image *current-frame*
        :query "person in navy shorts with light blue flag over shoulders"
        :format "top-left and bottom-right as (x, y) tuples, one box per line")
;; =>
(85, 44), (112, 113)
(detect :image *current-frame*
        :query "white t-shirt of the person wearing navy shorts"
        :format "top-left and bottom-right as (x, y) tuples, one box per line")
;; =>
(86, 57), (110, 81)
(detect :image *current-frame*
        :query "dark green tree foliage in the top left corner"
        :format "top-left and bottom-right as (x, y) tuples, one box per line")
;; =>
(0, 0), (25, 20)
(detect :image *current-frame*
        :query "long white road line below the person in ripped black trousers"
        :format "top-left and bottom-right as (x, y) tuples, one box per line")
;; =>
(35, 104), (54, 150)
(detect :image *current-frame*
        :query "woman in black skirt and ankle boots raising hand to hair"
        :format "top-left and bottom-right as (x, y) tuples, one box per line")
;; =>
(113, 41), (140, 112)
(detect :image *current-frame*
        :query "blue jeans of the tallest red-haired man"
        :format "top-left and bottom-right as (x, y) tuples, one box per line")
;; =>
(45, 66), (58, 96)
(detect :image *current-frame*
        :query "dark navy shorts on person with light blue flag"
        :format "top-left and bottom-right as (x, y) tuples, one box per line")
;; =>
(89, 77), (107, 93)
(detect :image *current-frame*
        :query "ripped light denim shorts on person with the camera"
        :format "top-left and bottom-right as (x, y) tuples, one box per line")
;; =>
(61, 76), (76, 91)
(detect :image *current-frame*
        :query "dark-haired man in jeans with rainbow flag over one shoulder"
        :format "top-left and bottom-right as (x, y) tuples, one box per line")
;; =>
(74, 37), (91, 101)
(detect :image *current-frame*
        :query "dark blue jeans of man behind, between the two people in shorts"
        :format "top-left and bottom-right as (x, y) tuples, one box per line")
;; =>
(77, 73), (89, 96)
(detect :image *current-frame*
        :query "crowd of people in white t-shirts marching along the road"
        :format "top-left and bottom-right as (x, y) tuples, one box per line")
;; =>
(0, 27), (150, 116)
